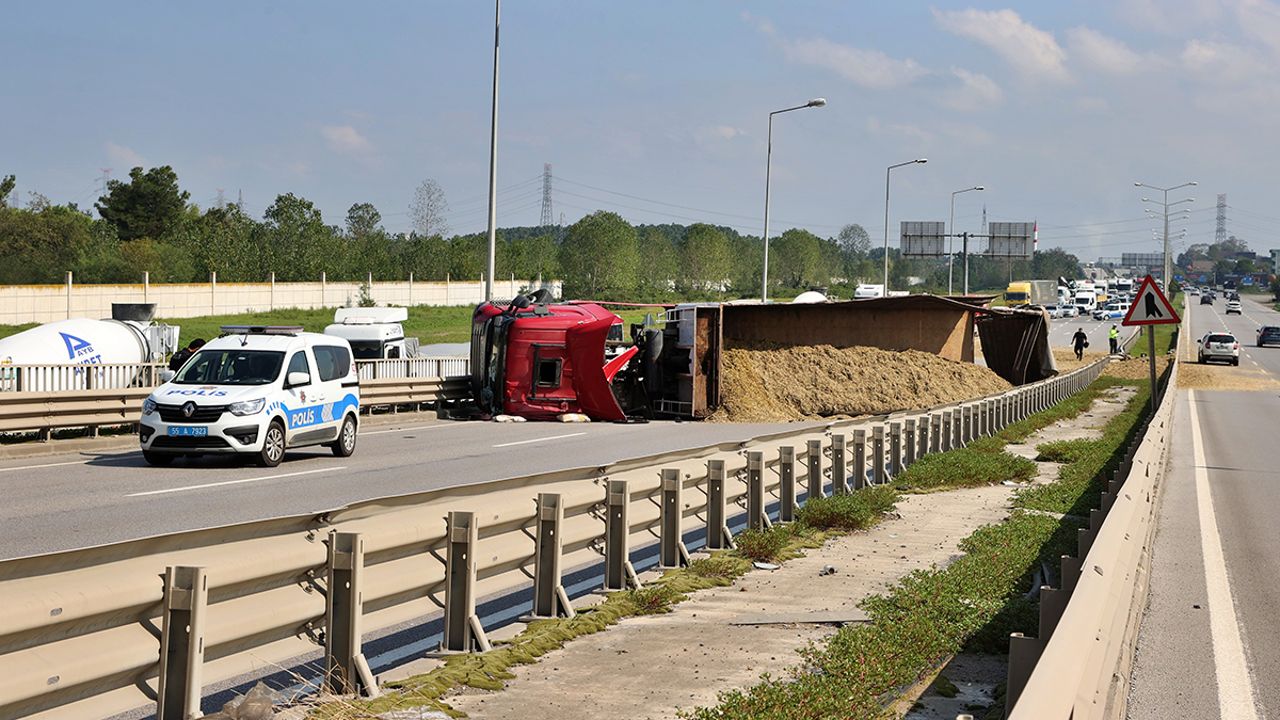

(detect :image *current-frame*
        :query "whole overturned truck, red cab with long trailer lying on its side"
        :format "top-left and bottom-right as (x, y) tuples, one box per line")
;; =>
(471, 293), (1056, 421)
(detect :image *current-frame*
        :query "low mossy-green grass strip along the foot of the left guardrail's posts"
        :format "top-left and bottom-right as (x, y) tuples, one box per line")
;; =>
(310, 487), (897, 720)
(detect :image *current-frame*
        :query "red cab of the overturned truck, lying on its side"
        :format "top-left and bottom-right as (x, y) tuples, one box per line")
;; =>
(471, 297), (635, 421)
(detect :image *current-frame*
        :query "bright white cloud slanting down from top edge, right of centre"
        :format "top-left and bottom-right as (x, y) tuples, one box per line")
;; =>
(933, 8), (1070, 81)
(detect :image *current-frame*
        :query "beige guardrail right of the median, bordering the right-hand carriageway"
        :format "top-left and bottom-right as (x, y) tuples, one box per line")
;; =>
(1006, 351), (1178, 720)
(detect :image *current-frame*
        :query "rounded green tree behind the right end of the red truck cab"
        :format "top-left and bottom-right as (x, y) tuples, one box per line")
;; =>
(559, 210), (640, 299)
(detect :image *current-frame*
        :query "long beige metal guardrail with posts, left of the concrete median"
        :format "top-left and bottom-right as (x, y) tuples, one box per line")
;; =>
(0, 360), (1106, 720)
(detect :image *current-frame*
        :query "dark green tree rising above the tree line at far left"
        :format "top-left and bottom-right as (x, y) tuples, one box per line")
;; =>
(95, 165), (191, 241)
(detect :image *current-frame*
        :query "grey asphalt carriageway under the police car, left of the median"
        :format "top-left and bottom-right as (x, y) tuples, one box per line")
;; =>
(0, 415), (819, 559)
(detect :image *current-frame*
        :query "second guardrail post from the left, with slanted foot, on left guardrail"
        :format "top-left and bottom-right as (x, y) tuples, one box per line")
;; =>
(324, 530), (378, 697)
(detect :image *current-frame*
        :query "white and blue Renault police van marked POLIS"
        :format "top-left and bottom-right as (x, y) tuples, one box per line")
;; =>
(138, 325), (360, 468)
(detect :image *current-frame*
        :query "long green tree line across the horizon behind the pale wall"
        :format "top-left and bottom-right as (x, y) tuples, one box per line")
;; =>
(0, 167), (1078, 301)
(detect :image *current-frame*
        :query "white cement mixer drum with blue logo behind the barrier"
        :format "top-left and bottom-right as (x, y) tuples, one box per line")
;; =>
(0, 304), (178, 392)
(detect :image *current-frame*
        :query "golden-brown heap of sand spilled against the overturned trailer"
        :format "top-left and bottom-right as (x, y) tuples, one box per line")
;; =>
(709, 345), (1010, 423)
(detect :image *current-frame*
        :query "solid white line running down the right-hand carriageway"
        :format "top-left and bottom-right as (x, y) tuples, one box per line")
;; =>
(1187, 389), (1258, 720)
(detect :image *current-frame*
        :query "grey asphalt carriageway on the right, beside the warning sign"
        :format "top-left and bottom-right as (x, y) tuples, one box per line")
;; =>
(1129, 293), (1280, 720)
